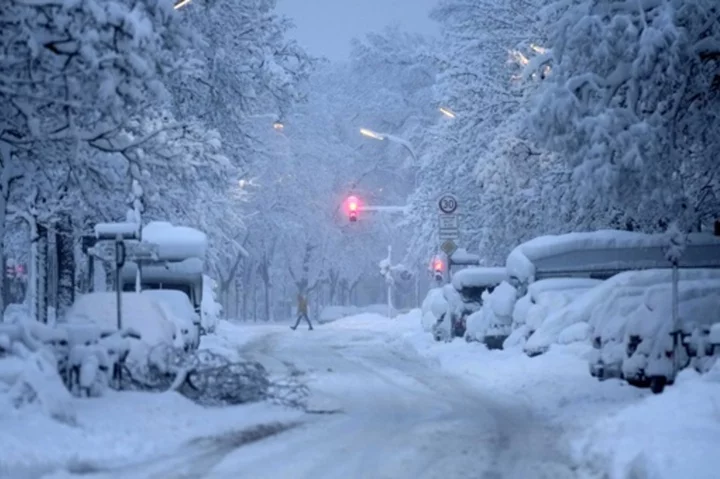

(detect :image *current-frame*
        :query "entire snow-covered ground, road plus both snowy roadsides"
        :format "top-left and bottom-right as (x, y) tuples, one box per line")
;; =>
(5, 314), (720, 479)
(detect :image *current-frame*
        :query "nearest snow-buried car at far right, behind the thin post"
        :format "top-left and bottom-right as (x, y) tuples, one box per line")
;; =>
(622, 280), (720, 392)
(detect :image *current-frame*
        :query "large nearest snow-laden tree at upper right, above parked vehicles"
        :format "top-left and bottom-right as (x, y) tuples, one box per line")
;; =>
(526, 0), (720, 230)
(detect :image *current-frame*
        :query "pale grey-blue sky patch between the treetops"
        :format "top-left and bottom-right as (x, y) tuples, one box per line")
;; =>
(278, 0), (437, 60)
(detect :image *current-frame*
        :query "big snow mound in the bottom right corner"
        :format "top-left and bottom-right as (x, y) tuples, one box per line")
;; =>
(574, 372), (720, 479)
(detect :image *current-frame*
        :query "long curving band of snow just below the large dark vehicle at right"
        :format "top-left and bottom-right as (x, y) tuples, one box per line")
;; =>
(525, 269), (720, 355)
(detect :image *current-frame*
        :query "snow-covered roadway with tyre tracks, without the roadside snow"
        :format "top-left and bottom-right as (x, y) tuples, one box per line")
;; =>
(56, 321), (576, 479)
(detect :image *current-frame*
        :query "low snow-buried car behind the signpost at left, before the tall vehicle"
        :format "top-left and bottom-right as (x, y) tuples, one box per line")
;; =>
(62, 292), (178, 363)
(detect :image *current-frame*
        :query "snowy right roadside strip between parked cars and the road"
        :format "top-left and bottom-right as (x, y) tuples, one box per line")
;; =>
(386, 313), (720, 479)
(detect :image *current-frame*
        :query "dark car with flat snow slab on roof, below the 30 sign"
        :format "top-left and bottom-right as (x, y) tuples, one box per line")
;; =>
(433, 267), (508, 341)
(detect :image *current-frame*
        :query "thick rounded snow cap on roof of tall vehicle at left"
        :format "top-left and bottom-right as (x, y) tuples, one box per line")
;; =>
(142, 221), (207, 261)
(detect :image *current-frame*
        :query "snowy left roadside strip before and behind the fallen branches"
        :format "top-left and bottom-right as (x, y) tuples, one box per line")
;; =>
(0, 322), (303, 479)
